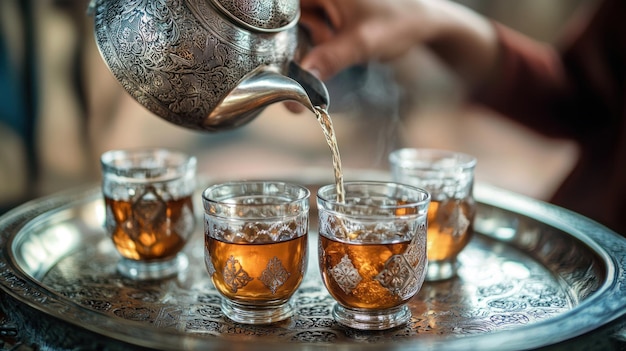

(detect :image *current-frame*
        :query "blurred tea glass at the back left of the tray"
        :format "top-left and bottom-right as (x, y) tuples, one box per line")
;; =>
(100, 149), (196, 280)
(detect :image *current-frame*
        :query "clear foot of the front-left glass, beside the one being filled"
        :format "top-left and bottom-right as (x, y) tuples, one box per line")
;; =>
(221, 298), (294, 324)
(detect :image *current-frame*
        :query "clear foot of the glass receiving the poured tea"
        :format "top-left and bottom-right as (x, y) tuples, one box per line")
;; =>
(333, 304), (411, 330)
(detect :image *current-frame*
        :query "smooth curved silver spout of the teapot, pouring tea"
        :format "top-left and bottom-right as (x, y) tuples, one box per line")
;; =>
(203, 62), (330, 131)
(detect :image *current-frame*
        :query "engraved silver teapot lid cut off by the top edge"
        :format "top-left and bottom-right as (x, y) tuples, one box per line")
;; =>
(211, 0), (300, 32)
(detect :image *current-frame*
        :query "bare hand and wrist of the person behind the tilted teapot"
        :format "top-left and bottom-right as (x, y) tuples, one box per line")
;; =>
(286, 0), (499, 112)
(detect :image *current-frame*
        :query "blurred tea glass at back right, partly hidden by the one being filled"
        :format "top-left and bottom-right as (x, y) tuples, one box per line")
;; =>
(389, 148), (476, 281)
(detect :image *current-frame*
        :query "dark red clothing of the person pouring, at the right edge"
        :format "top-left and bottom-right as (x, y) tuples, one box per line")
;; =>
(475, 0), (626, 236)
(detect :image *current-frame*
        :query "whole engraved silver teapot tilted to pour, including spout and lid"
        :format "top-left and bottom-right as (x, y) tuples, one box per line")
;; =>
(89, 0), (329, 131)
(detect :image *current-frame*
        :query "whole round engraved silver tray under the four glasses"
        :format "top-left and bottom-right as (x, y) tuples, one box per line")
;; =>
(0, 177), (626, 350)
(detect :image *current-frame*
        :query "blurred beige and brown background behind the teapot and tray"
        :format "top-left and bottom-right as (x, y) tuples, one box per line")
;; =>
(0, 0), (591, 213)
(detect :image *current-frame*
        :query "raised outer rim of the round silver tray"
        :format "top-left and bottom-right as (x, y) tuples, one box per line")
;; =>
(0, 176), (626, 350)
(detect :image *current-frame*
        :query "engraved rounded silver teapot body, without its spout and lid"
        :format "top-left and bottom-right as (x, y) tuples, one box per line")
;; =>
(93, 0), (298, 130)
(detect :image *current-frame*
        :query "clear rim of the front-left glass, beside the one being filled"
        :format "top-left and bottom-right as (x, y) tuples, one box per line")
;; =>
(202, 180), (311, 208)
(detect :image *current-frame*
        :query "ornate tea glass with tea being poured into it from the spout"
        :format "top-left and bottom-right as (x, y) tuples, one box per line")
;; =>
(317, 182), (430, 330)
